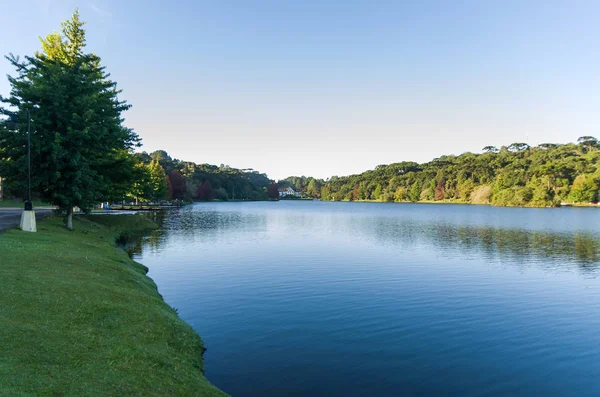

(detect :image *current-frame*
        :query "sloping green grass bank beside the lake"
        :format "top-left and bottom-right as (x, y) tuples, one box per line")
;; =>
(0, 215), (225, 396)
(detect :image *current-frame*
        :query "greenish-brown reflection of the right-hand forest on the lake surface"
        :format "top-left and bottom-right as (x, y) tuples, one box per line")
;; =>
(365, 219), (600, 269)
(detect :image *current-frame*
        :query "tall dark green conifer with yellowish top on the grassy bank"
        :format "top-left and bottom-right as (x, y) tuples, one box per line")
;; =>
(0, 11), (139, 229)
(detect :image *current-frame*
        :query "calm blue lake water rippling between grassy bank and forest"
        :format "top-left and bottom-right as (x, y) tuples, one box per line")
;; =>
(136, 202), (600, 396)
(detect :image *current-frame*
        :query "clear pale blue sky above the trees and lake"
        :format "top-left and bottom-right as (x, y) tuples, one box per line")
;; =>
(0, 0), (600, 179)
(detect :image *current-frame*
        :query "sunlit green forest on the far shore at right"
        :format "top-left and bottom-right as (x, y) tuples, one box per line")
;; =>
(279, 136), (600, 207)
